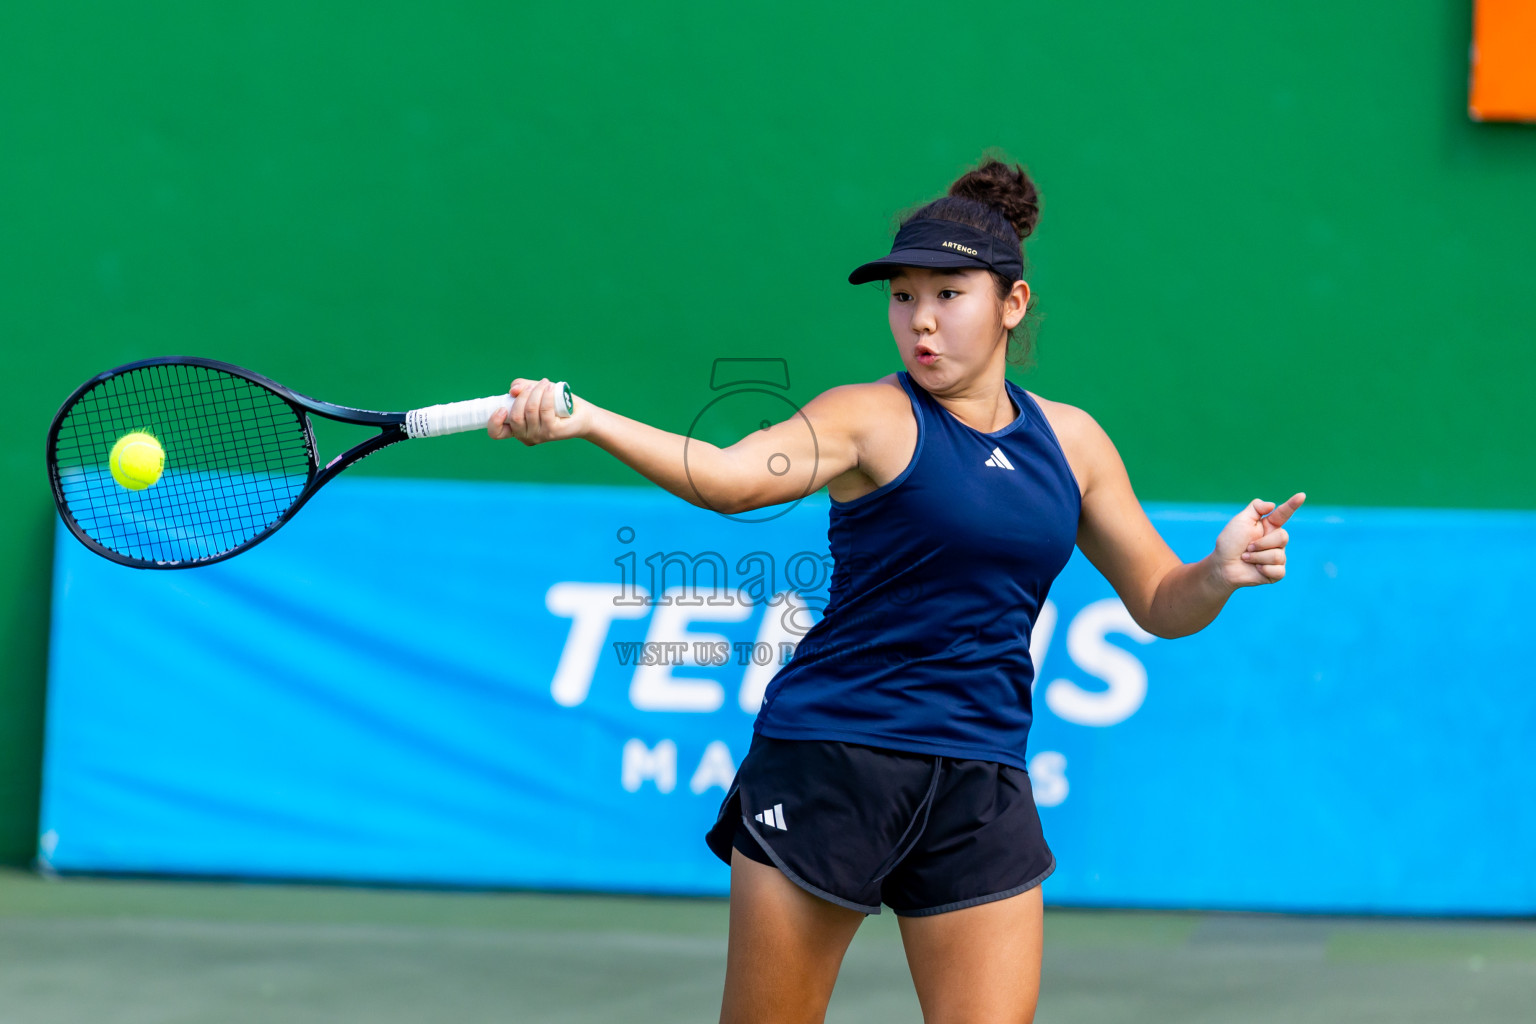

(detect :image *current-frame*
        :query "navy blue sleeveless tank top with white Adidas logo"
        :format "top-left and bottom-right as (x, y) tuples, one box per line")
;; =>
(754, 372), (1081, 768)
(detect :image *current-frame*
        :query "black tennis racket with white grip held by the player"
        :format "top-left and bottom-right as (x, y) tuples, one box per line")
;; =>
(48, 356), (573, 570)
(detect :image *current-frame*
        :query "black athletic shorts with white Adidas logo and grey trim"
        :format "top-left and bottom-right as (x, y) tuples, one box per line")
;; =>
(705, 734), (1055, 917)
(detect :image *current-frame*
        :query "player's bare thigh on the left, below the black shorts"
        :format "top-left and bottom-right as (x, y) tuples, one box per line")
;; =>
(720, 851), (865, 1024)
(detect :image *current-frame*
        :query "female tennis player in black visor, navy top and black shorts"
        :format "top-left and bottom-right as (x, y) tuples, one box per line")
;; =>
(490, 160), (1306, 1024)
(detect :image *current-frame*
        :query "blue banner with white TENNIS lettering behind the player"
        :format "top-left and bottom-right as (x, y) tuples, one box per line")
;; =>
(38, 479), (1536, 913)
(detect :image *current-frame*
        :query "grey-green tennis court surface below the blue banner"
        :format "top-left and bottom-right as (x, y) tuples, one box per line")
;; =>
(0, 870), (1536, 1024)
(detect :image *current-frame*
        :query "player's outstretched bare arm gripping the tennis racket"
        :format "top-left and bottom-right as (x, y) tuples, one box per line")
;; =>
(488, 379), (859, 514)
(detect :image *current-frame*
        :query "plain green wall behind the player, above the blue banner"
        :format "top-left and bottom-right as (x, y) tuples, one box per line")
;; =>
(0, 0), (1536, 861)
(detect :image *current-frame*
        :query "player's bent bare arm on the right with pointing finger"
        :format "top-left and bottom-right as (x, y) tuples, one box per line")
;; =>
(1074, 410), (1307, 637)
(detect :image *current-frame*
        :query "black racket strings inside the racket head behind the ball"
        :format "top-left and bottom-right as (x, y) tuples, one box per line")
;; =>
(55, 364), (313, 562)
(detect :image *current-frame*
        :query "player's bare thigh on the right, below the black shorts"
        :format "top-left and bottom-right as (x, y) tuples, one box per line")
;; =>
(900, 886), (1044, 1024)
